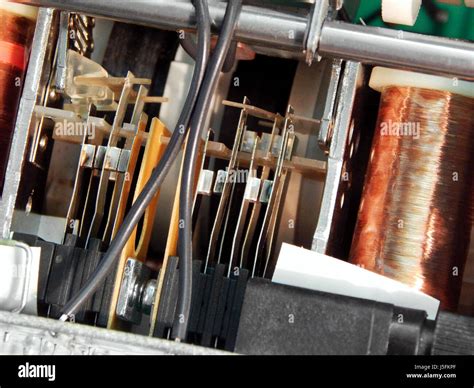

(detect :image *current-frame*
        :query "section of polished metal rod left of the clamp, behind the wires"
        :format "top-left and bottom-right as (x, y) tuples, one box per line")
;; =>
(13, 0), (307, 52)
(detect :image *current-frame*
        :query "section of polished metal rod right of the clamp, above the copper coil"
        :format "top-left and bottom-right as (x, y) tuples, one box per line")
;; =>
(319, 21), (474, 80)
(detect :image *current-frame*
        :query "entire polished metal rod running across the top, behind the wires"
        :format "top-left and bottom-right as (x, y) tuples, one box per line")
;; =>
(6, 0), (474, 80)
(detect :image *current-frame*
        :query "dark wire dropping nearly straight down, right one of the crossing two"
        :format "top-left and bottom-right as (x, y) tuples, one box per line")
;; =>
(173, 0), (242, 341)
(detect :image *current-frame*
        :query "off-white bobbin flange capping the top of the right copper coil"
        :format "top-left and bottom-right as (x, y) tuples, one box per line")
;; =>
(369, 67), (474, 98)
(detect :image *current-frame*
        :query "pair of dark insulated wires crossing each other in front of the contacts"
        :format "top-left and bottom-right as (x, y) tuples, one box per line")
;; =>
(61, 0), (242, 341)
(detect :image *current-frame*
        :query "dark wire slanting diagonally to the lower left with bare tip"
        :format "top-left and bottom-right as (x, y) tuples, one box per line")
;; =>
(61, 0), (211, 320)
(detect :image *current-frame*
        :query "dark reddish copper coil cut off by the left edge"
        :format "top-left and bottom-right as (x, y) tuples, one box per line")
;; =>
(0, 10), (35, 195)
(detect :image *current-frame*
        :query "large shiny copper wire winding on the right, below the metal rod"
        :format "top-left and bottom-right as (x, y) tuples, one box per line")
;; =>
(350, 87), (474, 311)
